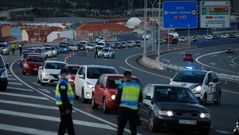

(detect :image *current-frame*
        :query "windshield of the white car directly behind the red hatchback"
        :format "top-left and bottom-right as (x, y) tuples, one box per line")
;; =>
(87, 67), (116, 79)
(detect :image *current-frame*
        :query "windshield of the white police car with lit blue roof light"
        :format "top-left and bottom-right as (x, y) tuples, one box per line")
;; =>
(173, 71), (206, 84)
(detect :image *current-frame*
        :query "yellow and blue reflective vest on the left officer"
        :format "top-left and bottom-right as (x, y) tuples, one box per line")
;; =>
(55, 79), (74, 105)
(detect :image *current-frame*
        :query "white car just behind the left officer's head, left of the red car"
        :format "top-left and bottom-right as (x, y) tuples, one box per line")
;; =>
(38, 61), (67, 85)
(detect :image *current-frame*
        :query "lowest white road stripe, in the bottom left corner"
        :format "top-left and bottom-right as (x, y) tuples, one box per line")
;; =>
(0, 124), (57, 135)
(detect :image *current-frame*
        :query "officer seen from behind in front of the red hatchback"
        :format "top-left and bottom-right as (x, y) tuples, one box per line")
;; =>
(116, 71), (143, 135)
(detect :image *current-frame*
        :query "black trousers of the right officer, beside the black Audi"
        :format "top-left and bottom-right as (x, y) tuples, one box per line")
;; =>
(117, 108), (138, 135)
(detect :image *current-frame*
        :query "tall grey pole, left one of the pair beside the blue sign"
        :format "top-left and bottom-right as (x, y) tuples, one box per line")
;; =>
(143, 0), (148, 57)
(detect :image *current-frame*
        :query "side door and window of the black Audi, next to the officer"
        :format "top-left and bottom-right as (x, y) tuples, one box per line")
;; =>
(140, 85), (154, 120)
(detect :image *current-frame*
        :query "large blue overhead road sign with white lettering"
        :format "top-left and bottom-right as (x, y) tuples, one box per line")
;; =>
(163, 1), (198, 29)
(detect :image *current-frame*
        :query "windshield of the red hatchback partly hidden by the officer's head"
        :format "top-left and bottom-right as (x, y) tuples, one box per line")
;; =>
(107, 77), (142, 89)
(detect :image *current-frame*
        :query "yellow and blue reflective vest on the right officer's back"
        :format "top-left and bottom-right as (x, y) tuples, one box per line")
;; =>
(120, 82), (140, 110)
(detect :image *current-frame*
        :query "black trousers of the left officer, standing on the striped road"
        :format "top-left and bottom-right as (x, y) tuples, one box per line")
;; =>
(58, 113), (75, 135)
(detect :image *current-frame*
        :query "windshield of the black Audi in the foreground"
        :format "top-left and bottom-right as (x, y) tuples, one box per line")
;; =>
(154, 86), (198, 104)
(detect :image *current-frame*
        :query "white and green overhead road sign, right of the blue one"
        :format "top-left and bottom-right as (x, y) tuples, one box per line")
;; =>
(200, 1), (231, 28)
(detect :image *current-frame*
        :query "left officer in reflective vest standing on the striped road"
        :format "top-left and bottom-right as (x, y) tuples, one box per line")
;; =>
(55, 69), (75, 135)
